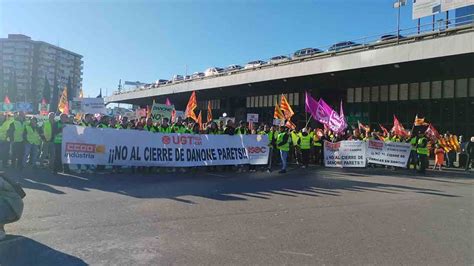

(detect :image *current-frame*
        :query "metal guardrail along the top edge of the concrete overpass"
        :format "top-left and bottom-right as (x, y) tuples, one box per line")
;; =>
(113, 15), (474, 95)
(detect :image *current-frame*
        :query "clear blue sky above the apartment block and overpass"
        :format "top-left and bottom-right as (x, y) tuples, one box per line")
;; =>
(0, 0), (452, 97)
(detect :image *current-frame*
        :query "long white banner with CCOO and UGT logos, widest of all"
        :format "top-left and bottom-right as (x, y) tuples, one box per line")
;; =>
(62, 125), (269, 167)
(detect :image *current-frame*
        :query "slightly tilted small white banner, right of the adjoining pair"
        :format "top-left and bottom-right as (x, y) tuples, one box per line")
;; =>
(367, 140), (411, 167)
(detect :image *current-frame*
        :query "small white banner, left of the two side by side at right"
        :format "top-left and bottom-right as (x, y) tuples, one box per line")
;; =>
(324, 140), (366, 168)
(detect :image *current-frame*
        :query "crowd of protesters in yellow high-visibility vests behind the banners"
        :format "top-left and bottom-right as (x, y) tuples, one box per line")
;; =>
(0, 112), (474, 173)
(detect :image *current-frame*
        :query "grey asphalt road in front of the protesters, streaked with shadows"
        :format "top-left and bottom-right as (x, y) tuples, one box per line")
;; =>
(0, 168), (474, 265)
